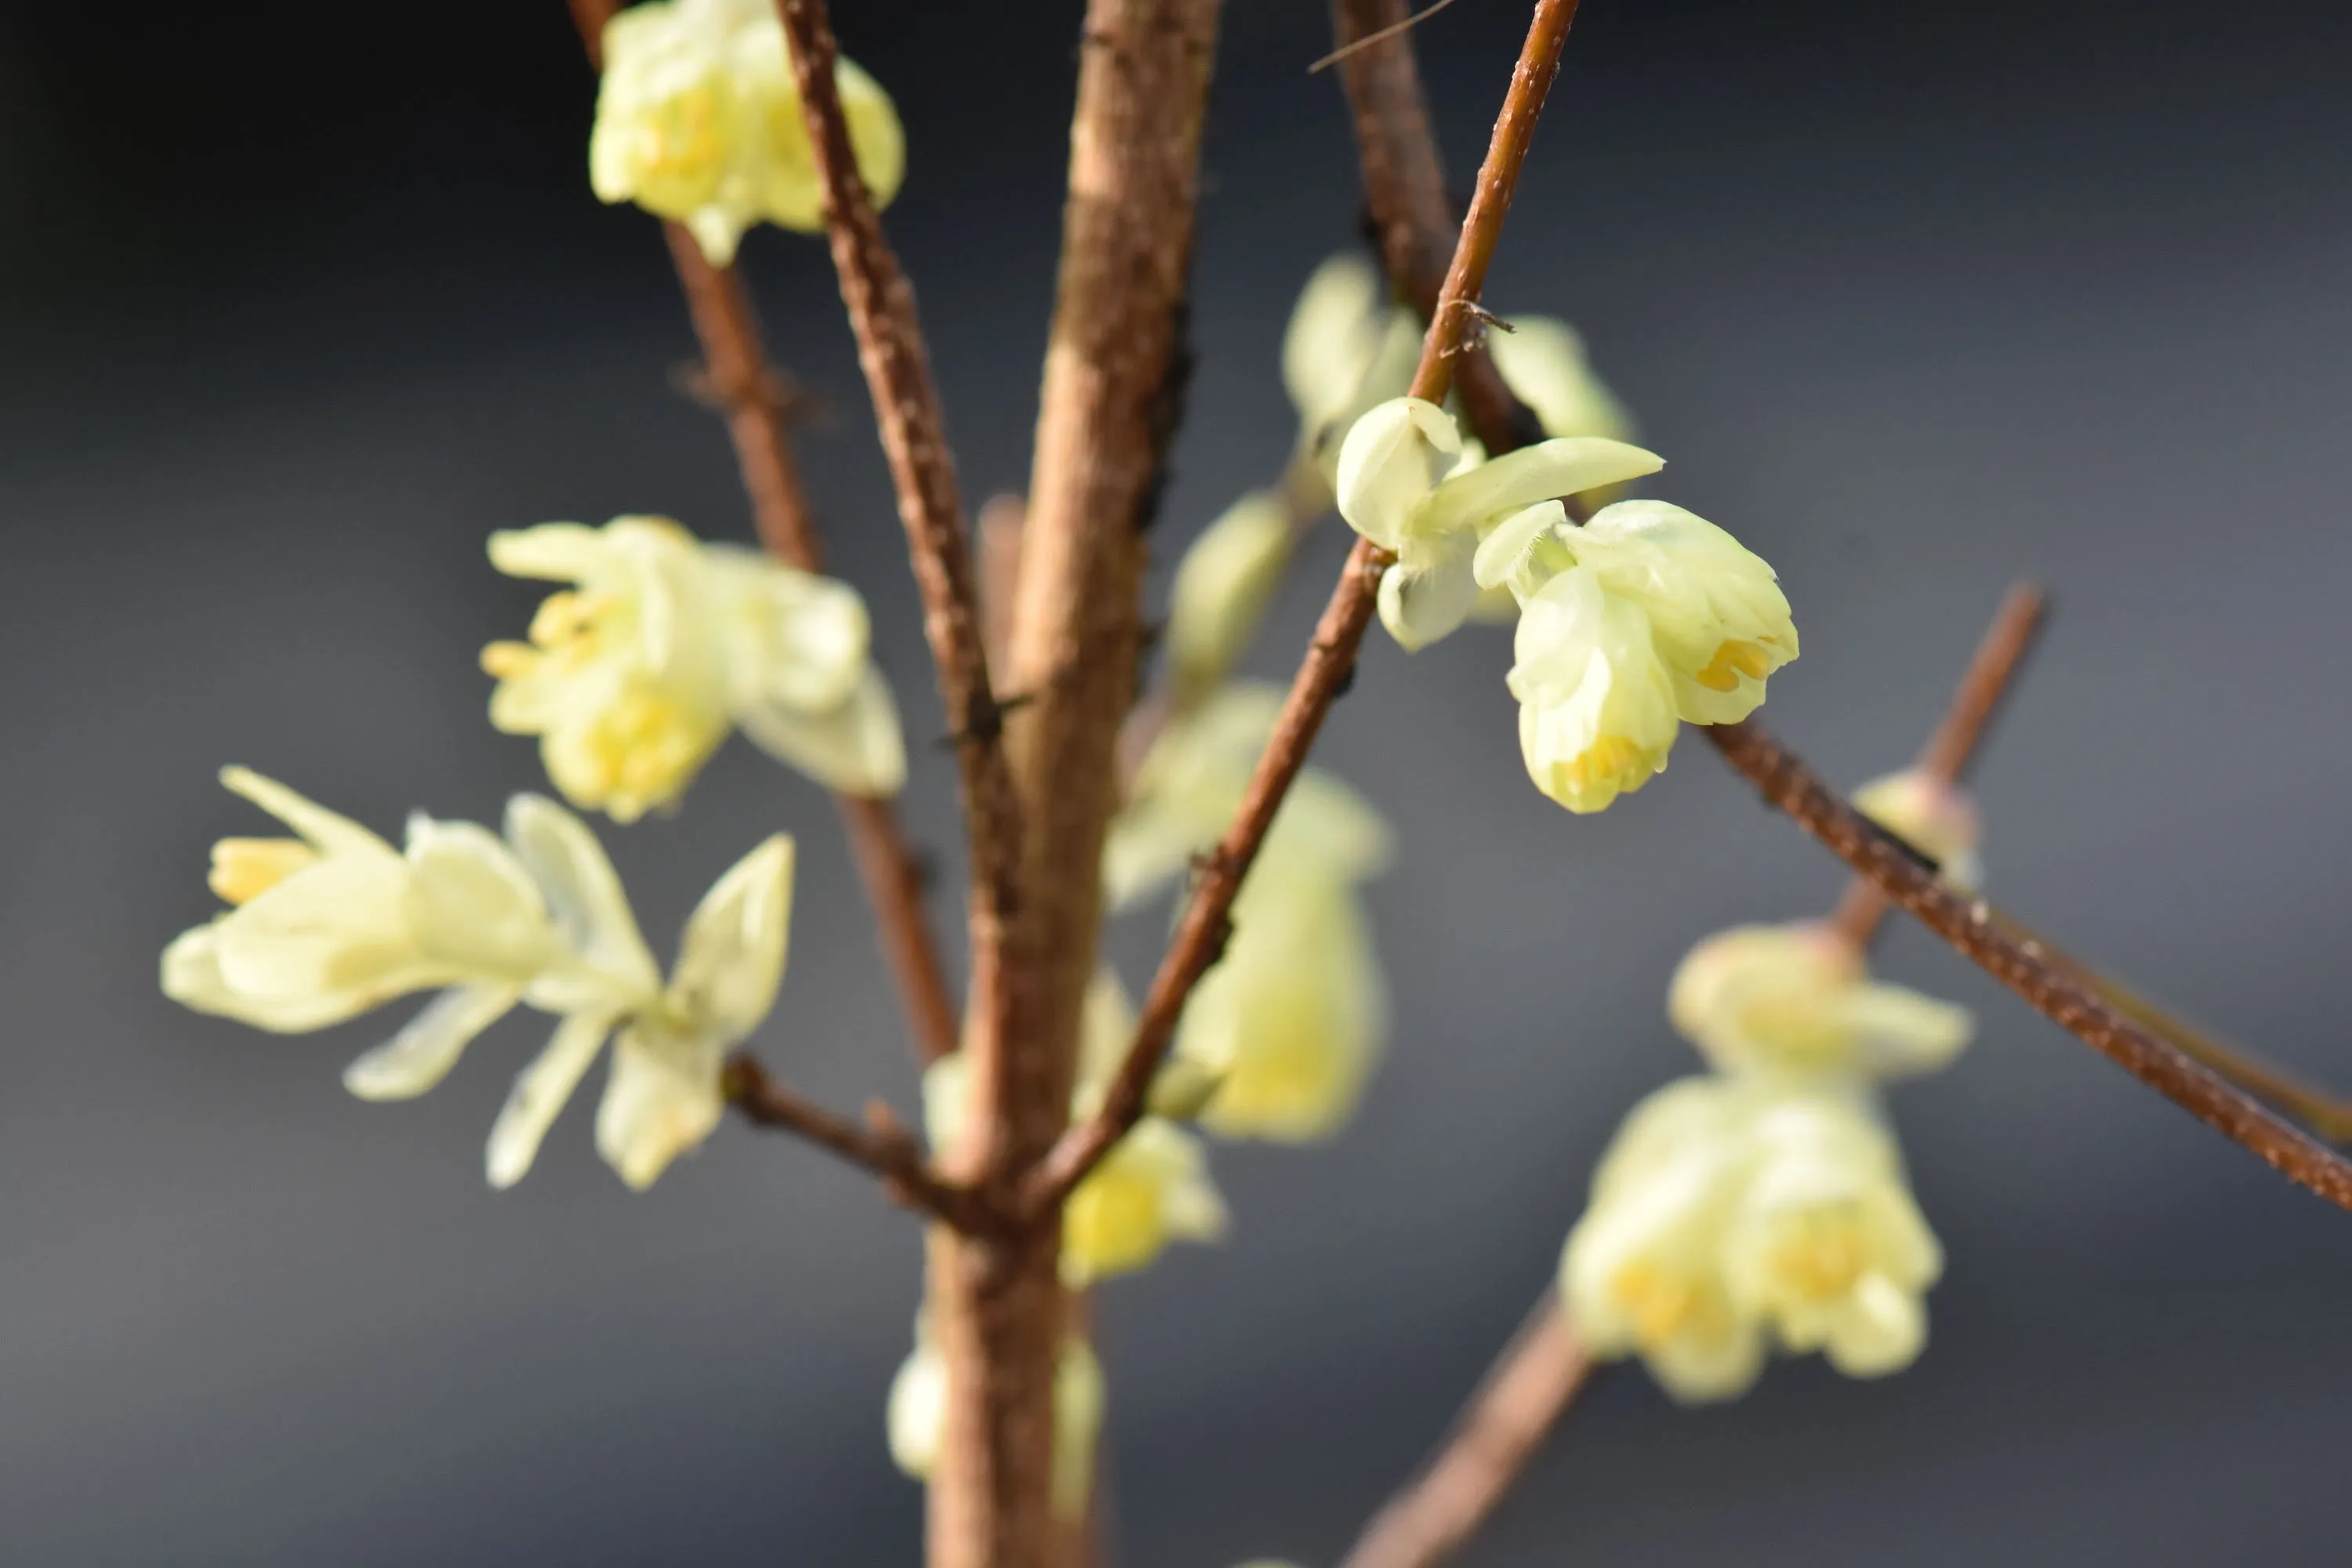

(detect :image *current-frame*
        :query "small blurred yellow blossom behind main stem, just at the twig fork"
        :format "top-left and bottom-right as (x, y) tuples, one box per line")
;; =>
(922, 971), (1228, 1288)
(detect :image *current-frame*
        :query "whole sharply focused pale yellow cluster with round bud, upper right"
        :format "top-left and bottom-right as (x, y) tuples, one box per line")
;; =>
(1338, 397), (1797, 811)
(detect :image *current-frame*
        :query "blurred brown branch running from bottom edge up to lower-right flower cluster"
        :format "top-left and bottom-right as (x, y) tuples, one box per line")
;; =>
(1341, 1290), (1595, 1568)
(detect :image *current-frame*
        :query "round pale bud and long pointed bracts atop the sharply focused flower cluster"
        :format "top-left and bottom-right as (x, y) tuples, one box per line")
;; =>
(1338, 397), (1665, 649)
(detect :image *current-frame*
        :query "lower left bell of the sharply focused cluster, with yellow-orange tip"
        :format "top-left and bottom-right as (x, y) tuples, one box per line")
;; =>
(1505, 569), (1679, 813)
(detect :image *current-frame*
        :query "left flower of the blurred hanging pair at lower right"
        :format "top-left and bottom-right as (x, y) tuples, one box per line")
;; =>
(1559, 1079), (1769, 1403)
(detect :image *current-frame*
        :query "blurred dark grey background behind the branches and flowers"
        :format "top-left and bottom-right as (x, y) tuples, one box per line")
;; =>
(0, 0), (2352, 1568)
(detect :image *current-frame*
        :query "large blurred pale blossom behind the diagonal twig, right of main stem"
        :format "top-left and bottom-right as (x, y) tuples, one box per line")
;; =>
(1103, 684), (1392, 1142)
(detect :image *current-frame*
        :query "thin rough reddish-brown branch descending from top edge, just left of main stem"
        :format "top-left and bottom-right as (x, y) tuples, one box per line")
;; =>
(776, 0), (1021, 1053)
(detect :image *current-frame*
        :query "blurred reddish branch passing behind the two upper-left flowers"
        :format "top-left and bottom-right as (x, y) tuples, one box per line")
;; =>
(572, 0), (957, 1062)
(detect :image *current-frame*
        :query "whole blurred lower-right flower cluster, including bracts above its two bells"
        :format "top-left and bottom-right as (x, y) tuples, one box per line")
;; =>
(1562, 785), (1976, 1401)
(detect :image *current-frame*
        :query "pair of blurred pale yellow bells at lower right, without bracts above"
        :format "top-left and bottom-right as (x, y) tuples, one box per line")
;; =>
(1559, 1076), (1943, 1401)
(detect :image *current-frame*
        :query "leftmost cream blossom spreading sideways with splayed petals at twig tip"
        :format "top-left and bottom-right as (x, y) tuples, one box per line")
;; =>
(162, 769), (793, 1187)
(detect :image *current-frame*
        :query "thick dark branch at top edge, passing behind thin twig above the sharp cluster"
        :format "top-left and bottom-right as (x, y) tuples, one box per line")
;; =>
(1331, 0), (1573, 472)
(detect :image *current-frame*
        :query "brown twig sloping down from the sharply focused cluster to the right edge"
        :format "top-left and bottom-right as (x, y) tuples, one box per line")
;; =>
(1700, 720), (2352, 1208)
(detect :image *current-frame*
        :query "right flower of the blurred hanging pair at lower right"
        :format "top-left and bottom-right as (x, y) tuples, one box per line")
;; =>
(1724, 1093), (1943, 1377)
